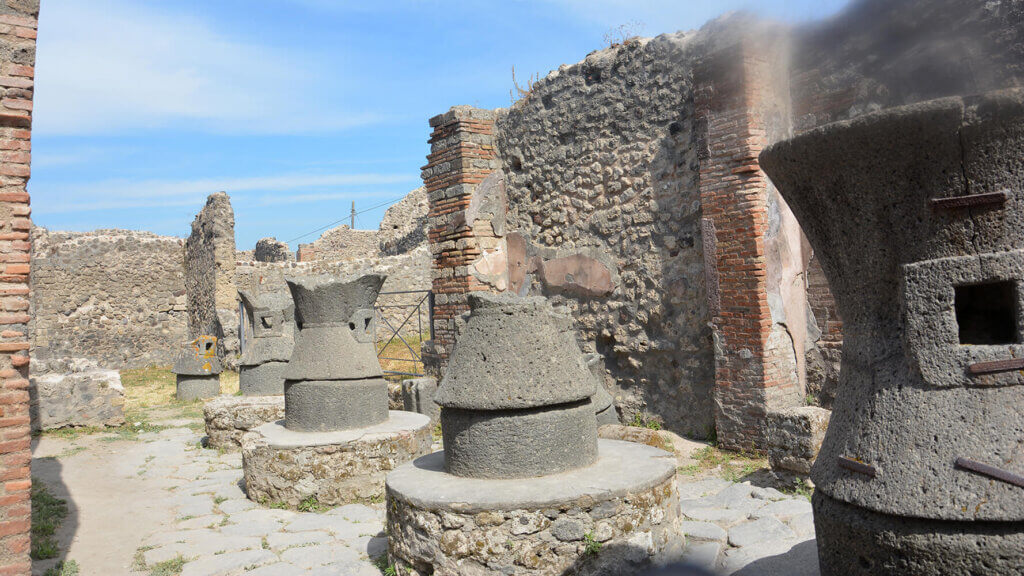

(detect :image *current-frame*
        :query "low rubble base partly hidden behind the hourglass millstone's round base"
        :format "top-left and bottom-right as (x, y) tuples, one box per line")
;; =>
(203, 396), (285, 451)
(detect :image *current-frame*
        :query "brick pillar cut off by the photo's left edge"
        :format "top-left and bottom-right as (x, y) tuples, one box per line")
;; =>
(0, 1), (39, 576)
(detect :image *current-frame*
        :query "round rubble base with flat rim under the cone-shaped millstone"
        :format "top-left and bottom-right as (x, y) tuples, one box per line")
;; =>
(387, 440), (684, 576)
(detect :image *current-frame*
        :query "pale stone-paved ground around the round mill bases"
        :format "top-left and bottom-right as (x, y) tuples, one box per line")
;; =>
(32, 420), (817, 576)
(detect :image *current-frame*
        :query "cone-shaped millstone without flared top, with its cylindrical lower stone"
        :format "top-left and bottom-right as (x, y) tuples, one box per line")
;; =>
(434, 295), (597, 478)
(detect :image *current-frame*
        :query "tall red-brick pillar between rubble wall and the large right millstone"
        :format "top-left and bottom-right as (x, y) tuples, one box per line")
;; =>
(694, 41), (799, 450)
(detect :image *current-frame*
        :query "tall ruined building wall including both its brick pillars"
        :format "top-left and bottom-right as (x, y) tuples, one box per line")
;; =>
(423, 0), (1024, 448)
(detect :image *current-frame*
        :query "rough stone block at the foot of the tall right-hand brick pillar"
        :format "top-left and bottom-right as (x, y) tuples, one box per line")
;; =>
(767, 406), (831, 477)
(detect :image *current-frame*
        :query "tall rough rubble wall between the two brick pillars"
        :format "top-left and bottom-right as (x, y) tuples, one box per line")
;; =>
(496, 33), (715, 437)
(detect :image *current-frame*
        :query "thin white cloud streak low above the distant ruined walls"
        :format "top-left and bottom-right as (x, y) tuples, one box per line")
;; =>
(32, 173), (419, 215)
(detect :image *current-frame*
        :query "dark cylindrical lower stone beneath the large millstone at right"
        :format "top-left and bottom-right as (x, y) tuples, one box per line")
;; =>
(811, 490), (1024, 576)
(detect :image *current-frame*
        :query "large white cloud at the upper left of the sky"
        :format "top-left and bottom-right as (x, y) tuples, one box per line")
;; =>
(34, 0), (382, 134)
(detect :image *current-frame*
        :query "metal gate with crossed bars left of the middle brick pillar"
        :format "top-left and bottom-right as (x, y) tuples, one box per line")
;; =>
(374, 290), (434, 376)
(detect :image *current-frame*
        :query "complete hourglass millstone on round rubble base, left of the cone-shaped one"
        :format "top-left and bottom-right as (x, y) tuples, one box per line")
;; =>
(285, 275), (388, 431)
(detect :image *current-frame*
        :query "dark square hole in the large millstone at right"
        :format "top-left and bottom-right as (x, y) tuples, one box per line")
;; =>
(954, 282), (1018, 344)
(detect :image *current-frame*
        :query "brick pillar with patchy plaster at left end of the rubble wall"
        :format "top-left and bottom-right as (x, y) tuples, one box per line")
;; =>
(422, 106), (499, 372)
